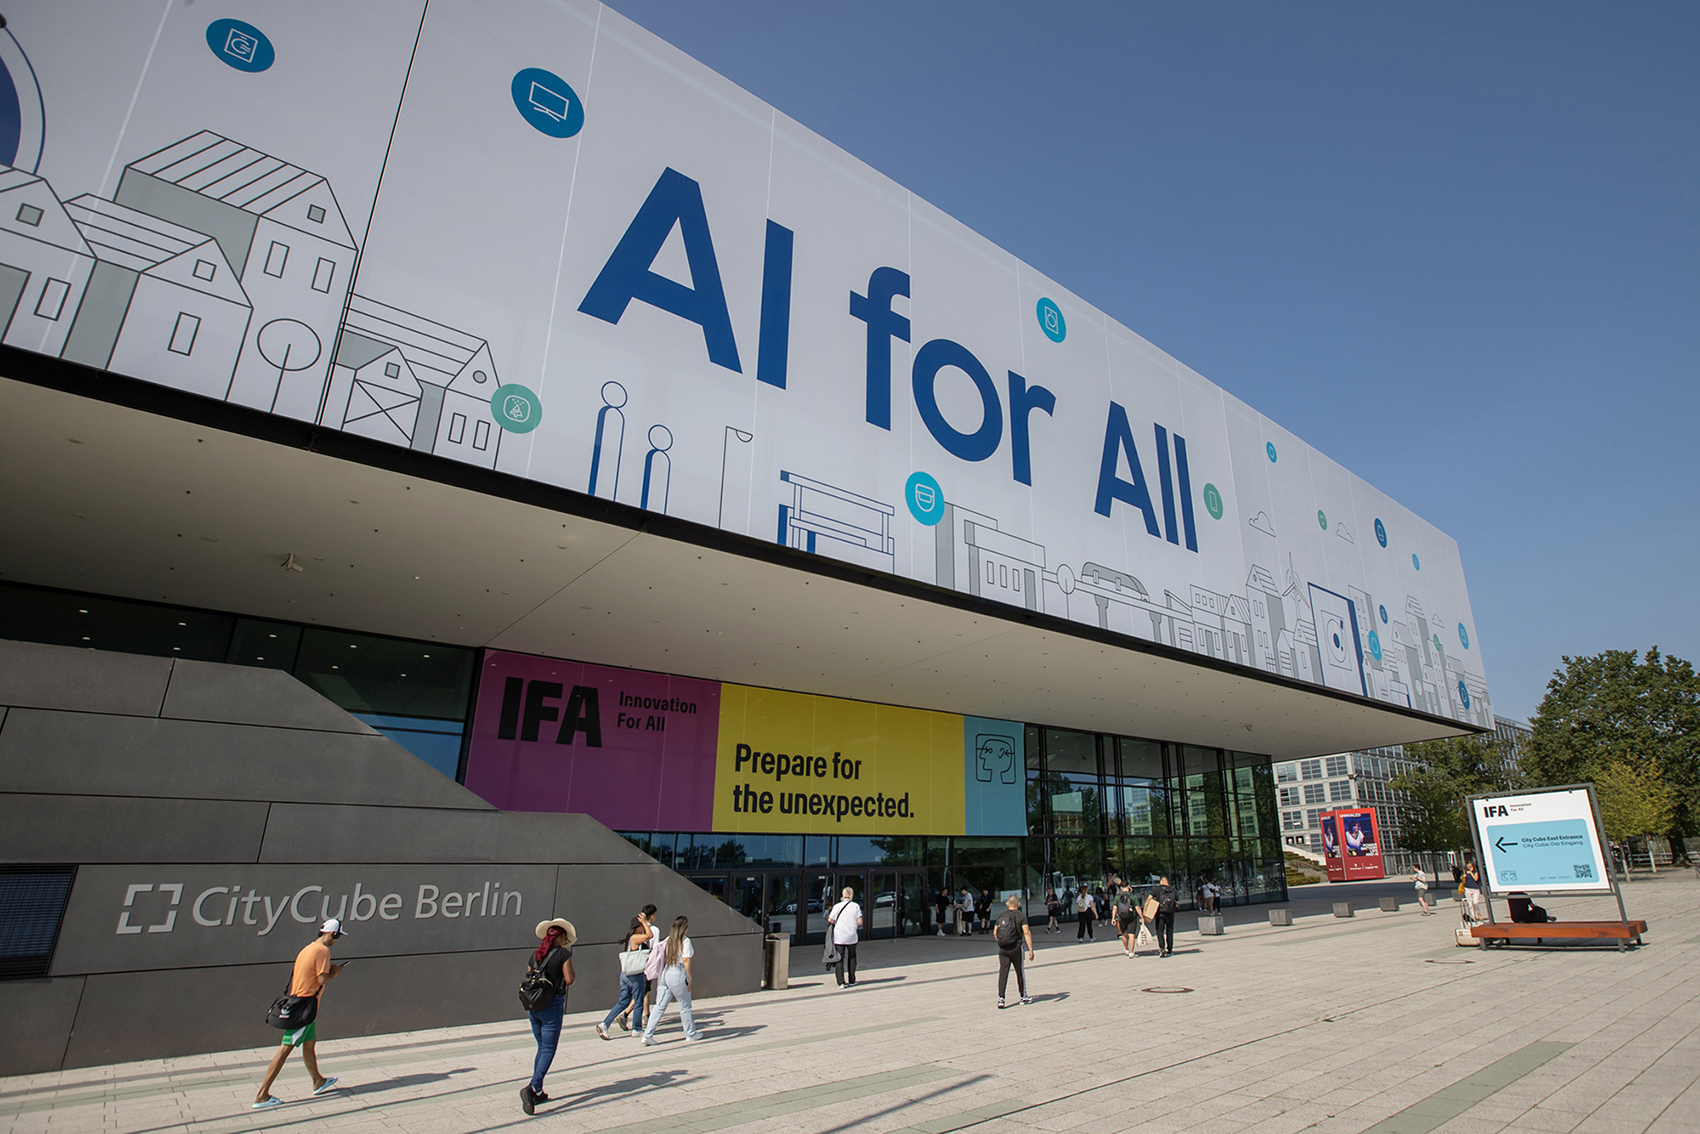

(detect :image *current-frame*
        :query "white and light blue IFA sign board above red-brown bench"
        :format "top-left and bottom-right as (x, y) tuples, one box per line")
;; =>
(1471, 785), (1612, 894)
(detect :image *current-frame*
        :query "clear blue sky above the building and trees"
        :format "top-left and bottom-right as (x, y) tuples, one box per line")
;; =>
(614, 0), (1700, 717)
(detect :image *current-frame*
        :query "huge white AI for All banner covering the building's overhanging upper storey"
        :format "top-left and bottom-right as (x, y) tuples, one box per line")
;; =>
(0, 0), (1493, 728)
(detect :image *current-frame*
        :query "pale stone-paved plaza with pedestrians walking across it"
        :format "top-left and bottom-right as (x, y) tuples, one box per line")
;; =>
(0, 870), (1700, 1134)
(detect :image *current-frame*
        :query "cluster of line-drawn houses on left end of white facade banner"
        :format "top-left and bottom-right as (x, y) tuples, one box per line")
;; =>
(0, 131), (506, 468)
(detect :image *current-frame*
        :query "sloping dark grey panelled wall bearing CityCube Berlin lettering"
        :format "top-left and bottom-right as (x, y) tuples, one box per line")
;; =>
(0, 641), (762, 1074)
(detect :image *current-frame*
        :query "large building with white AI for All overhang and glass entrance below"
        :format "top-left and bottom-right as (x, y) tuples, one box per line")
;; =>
(0, 0), (1494, 1067)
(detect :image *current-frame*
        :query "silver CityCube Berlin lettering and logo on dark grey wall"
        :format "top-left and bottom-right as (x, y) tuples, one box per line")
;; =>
(114, 879), (525, 937)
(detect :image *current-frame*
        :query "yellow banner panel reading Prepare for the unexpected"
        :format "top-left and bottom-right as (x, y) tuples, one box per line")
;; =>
(714, 685), (964, 835)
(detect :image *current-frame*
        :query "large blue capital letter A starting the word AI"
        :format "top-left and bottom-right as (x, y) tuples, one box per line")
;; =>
(578, 168), (743, 374)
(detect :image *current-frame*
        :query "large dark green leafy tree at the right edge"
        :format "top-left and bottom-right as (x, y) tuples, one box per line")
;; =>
(1523, 648), (1700, 845)
